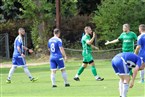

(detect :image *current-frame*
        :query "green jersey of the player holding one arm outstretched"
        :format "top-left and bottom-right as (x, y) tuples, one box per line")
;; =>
(118, 32), (137, 52)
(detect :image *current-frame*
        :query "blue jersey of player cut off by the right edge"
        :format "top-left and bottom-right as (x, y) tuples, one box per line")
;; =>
(137, 33), (145, 61)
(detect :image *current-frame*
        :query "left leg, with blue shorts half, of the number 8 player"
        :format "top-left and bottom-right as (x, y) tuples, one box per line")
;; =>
(50, 58), (57, 87)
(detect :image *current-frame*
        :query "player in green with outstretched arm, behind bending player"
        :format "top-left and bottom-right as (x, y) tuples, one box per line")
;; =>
(105, 24), (137, 52)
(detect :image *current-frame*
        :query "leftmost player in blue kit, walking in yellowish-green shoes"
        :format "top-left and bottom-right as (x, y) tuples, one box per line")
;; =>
(6, 28), (38, 83)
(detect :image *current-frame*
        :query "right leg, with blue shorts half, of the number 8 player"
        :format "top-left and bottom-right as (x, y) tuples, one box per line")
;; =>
(56, 58), (70, 87)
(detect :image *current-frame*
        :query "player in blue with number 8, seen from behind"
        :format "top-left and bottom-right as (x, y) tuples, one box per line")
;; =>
(48, 28), (70, 87)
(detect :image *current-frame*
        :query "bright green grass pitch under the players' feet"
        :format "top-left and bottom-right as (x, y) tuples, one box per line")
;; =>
(0, 60), (145, 97)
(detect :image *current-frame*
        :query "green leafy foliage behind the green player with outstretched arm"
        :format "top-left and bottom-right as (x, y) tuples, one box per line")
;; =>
(92, 0), (145, 47)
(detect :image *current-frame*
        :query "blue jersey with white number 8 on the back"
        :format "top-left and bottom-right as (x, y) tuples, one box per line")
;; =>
(48, 37), (62, 58)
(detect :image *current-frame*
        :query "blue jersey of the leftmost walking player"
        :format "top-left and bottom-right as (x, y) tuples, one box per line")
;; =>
(13, 35), (23, 57)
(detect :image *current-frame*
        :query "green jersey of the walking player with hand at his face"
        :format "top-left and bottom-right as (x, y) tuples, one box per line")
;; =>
(81, 35), (92, 54)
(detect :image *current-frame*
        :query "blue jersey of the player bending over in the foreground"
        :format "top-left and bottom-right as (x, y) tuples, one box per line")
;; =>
(114, 52), (142, 67)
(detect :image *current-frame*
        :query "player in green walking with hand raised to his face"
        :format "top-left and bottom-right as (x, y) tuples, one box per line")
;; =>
(74, 26), (104, 81)
